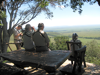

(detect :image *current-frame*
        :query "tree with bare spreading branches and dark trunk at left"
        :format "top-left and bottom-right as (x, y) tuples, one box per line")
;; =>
(0, 0), (57, 53)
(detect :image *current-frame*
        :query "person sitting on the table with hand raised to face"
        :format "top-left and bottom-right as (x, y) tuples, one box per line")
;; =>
(23, 24), (35, 51)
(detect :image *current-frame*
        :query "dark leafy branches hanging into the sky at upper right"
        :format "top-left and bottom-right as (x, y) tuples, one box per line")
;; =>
(55, 0), (100, 14)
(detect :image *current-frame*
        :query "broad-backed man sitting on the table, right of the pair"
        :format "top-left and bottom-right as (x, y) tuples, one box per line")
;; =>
(32, 23), (49, 52)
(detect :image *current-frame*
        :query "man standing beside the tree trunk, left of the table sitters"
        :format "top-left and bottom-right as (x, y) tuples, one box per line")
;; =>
(13, 25), (23, 50)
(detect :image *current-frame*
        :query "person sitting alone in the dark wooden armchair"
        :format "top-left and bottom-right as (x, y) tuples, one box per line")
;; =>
(69, 33), (81, 56)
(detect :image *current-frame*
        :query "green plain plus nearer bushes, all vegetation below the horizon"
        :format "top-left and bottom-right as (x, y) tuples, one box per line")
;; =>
(47, 26), (100, 65)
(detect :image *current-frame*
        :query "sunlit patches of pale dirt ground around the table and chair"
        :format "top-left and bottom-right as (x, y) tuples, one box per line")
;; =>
(6, 60), (100, 75)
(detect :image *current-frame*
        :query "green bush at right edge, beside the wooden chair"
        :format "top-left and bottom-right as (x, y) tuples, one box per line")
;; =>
(86, 40), (100, 65)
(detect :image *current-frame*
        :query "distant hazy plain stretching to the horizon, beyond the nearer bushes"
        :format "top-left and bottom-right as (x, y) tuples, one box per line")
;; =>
(45, 25), (100, 44)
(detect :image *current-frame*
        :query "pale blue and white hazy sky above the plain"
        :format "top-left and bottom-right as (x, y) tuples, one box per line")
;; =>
(29, 3), (100, 27)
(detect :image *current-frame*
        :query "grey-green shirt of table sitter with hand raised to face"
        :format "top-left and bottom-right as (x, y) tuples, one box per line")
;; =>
(23, 31), (35, 49)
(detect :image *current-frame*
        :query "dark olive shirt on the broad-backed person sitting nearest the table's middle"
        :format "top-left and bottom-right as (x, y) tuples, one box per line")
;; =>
(32, 30), (50, 46)
